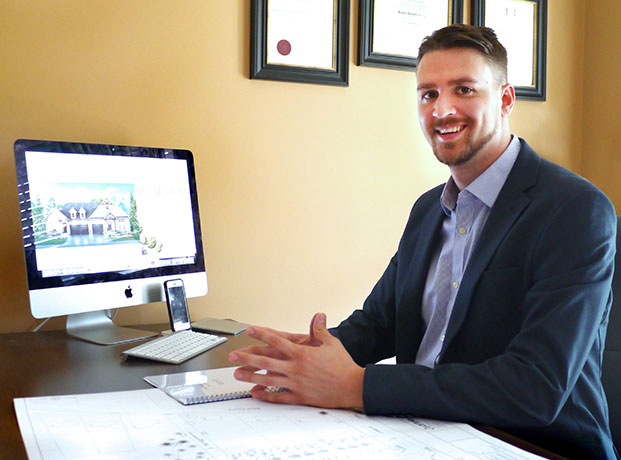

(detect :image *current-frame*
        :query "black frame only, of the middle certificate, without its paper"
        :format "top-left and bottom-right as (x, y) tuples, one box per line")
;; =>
(358, 0), (464, 70)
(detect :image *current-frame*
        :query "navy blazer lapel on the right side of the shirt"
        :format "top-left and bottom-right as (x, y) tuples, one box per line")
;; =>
(442, 139), (541, 351)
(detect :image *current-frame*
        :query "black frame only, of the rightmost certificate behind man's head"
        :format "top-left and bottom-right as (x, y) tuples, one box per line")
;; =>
(470, 0), (548, 101)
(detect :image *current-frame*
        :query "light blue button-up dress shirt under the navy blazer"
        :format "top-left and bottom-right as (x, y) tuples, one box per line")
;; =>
(416, 136), (520, 367)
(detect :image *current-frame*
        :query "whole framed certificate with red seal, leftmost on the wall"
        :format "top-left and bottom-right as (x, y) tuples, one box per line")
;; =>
(250, 0), (349, 86)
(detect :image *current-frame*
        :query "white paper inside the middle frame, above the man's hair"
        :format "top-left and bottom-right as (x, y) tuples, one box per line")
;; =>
(372, 0), (449, 57)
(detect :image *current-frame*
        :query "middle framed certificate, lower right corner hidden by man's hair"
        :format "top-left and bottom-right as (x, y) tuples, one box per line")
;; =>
(358, 0), (464, 70)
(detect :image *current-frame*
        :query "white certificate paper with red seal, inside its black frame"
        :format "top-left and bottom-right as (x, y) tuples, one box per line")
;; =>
(267, 0), (336, 70)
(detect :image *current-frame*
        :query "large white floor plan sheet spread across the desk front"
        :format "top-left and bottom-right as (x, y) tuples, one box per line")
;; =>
(14, 389), (541, 460)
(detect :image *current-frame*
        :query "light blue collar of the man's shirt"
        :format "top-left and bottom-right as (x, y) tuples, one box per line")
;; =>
(440, 135), (521, 216)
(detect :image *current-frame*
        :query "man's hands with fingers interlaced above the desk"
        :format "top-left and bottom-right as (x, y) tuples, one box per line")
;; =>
(229, 313), (364, 409)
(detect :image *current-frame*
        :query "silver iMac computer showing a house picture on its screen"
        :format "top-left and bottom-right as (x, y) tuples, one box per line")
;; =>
(15, 139), (207, 344)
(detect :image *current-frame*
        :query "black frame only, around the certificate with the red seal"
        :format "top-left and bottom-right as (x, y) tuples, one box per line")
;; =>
(250, 0), (350, 86)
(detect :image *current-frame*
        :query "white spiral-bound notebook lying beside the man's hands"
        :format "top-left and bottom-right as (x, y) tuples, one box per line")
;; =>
(144, 367), (254, 405)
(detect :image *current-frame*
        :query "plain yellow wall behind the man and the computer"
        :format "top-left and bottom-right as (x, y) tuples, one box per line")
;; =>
(0, 0), (619, 331)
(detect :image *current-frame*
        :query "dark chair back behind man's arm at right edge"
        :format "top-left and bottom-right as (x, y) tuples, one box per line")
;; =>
(602, 216), (621, 451)
